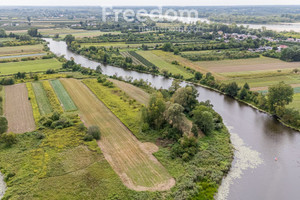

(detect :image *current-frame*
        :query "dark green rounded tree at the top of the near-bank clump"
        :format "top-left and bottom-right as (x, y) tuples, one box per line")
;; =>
(173, 86), (199, 112)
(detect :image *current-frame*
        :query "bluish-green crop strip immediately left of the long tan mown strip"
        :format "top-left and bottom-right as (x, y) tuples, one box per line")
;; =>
(51, 80), (77, 111)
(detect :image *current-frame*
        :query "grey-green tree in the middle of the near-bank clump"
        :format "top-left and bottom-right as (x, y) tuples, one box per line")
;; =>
(165, 102), (184, 130)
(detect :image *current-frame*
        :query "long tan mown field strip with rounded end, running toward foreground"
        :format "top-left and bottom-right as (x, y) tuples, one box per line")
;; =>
(61, 79), (175, 191)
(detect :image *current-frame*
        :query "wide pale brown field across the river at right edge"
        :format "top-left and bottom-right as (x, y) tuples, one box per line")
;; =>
(196, 57), (300, 73)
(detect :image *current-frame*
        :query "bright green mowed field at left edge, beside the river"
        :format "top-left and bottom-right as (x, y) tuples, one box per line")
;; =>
(0, 58), (61, 75)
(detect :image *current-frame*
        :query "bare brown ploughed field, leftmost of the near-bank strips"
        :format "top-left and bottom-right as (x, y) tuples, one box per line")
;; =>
(4, 84), (35, 133)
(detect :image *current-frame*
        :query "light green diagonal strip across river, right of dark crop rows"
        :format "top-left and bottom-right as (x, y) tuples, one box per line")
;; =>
(137, 51), (193, 78)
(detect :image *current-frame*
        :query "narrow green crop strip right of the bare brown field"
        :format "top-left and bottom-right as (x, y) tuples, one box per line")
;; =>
(32, 82), (53, 115)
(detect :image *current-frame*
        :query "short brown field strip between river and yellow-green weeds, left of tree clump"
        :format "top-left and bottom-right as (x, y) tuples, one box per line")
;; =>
(109, 79), (150, 105)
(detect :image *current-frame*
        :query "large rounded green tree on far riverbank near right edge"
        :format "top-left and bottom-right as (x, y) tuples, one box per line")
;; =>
(267, 82), (294, 112)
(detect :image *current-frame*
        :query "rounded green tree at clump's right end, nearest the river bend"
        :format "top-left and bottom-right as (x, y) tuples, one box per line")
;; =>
(193, 106), (215, 135)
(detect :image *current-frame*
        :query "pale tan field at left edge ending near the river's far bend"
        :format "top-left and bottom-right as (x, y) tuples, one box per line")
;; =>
(0, 44), (44, 56)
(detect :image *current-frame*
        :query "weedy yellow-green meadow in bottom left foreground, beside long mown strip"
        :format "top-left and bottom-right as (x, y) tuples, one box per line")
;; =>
(0, 125), (145, 200)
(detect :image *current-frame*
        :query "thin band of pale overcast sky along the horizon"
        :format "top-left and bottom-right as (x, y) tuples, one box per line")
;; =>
(0, 0), (300, 6)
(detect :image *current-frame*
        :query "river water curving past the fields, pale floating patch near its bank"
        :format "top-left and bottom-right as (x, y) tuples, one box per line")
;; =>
(45, 39), (300, 200)
